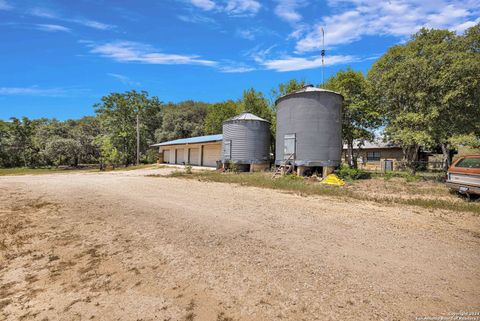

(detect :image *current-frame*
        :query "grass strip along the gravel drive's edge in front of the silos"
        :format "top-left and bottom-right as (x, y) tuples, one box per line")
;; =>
(157, 171), (480, 215)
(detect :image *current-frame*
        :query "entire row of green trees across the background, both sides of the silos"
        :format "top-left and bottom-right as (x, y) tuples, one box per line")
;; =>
(0, 24), (480, 170)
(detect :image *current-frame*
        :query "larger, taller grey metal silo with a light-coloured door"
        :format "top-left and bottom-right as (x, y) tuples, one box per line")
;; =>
(275, 86), (343, 167)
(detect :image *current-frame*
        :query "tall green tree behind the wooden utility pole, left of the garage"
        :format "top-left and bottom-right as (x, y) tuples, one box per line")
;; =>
(94, 90), (161, 166)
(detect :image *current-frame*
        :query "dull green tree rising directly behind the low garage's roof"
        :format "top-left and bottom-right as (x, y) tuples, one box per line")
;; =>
(155, 100), (209, 141)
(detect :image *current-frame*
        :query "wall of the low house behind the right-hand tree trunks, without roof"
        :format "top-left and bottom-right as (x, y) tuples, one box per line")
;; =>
(342, 148), (403, 171)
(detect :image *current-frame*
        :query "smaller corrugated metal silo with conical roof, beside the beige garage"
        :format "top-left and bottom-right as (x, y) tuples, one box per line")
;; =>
(222, 113), (270, 171)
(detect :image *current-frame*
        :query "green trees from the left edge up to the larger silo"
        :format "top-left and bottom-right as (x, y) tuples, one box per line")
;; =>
(0, 89), (274, 168)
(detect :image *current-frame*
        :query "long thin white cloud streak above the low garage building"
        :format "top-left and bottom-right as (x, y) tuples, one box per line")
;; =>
(90, 41), (217, 66)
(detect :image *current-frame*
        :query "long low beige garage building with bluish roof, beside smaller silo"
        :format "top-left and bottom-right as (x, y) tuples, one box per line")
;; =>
(151, 134), (223, 167)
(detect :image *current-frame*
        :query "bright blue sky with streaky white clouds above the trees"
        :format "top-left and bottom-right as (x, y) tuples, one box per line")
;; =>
(0, 0), (480, 119)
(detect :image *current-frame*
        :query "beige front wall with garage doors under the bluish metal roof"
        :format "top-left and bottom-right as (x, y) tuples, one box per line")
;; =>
(159, 141), (222, 167)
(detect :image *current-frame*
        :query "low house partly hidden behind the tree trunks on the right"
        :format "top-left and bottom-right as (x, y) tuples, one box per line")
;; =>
(342, 141), (431, 171)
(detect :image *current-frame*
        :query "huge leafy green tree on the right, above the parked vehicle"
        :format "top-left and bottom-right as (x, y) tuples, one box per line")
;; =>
(368, 25), (480, 172)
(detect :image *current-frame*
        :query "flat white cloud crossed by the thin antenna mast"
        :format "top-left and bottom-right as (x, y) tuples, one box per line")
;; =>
(260, 56), (358, 72)
